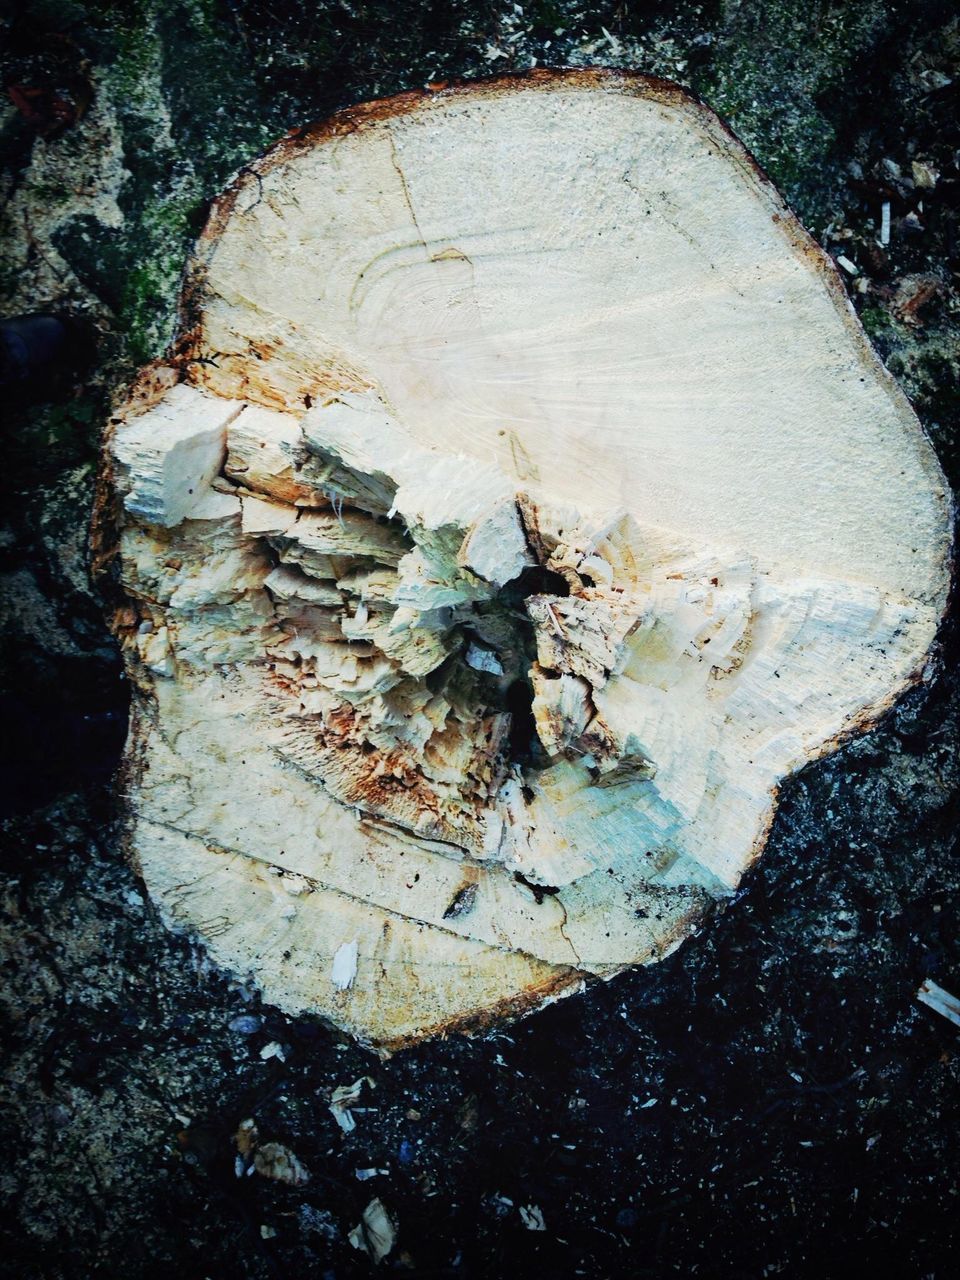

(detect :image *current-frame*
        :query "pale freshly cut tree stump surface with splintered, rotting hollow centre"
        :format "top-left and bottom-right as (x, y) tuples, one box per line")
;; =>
(97, 72), (950, 1050)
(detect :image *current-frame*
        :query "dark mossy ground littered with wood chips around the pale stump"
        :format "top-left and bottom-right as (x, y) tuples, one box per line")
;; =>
(0, 0), (960, 1280)
